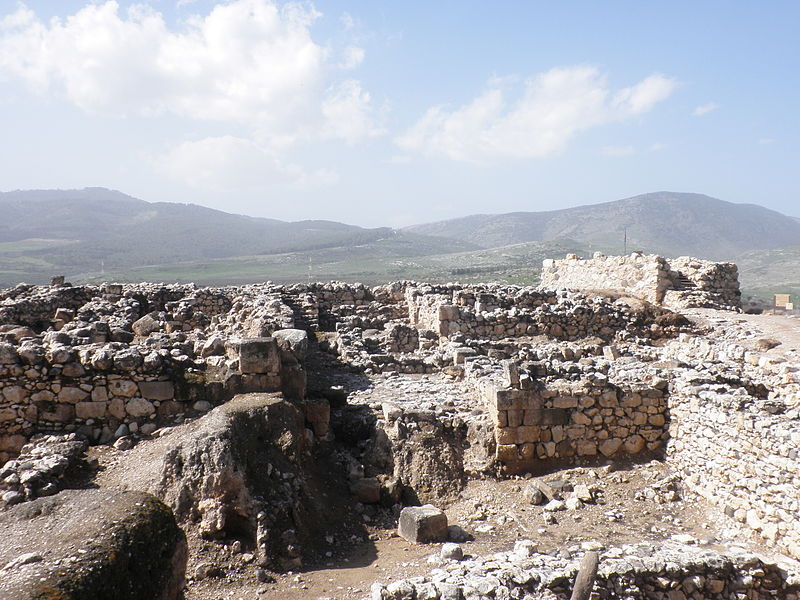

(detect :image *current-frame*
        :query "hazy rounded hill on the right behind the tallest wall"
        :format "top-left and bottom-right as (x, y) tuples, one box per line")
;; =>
(406, 192), (800, 259)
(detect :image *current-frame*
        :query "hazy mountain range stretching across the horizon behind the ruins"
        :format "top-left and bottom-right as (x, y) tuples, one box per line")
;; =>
(0, 188), (800, 302)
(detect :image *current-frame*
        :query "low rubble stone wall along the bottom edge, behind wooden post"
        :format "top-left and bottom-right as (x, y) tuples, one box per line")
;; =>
(370, 540), (800, 600)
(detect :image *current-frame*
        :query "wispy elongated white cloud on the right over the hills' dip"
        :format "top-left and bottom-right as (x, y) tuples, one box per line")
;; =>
(396, 67), (677, 163)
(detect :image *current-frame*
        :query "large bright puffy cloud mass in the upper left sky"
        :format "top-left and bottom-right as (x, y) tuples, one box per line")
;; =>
(0, 0), (382, 142)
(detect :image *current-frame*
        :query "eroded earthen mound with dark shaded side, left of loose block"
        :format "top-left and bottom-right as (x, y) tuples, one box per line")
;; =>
(154, 394), (314, 568)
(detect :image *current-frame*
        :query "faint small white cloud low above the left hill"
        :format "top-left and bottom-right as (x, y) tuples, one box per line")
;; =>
(159, 135), (337, 192)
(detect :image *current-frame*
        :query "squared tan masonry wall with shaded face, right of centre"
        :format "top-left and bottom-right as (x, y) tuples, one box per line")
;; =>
(479, 362), (667, 472)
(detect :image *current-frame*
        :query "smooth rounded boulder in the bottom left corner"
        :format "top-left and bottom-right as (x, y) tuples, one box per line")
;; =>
(0, 489), (187, 600)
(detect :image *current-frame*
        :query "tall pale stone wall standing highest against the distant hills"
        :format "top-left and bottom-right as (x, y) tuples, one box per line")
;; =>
(541, 252), (741, 309)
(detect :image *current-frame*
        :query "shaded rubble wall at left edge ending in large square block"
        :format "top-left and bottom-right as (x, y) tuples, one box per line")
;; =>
(0, 338), (282, 463)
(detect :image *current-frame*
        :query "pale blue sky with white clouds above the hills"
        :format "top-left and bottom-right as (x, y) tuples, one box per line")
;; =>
(0, 0), (800, 227)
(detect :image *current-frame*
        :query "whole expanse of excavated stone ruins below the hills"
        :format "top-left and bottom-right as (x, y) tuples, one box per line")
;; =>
(0, 253), (800, 600)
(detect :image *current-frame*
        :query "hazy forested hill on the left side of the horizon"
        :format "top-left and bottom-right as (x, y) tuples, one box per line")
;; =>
(0, 188), (479, 285)
